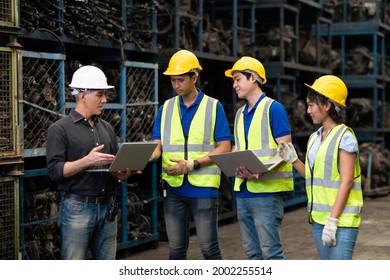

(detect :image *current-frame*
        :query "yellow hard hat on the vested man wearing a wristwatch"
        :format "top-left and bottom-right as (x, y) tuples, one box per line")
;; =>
(163, 50), (202, 76)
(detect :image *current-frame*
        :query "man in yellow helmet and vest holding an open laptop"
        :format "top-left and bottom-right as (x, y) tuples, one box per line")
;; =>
(225, 56), (294, 260)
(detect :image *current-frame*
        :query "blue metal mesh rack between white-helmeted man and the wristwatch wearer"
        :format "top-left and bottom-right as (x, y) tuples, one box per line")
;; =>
(118, 61), (159, 250)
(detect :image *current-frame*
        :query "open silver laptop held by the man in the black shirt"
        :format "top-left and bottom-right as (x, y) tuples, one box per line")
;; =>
(85, 142), (157, 172)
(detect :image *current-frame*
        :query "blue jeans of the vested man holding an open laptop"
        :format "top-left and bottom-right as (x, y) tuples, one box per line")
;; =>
(237, 196), (285, 260)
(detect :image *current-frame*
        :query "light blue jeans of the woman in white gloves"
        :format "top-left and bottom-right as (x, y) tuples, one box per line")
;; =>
(312, 223), (359, 260)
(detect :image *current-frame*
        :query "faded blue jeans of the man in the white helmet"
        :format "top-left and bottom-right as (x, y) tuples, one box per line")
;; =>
(57, 198), (117, 260)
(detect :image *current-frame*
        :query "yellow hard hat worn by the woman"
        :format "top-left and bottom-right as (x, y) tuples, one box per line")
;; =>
(305, 75), (348, 107)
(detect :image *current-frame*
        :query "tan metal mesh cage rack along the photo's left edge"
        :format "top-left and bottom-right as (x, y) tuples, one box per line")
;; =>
(0, 0), (23, 260)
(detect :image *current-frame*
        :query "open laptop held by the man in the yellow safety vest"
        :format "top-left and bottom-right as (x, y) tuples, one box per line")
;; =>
(209, 150), (283, 177)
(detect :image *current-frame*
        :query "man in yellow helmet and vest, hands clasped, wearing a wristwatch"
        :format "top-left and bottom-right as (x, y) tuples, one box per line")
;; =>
(152, 50), (231, 259)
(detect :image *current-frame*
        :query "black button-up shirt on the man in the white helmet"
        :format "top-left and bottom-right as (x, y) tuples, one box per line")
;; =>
(46, 109), (118, 196)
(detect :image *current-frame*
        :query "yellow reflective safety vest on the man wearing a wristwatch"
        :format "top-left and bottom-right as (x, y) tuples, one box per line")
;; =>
(161, 95), (221, 188)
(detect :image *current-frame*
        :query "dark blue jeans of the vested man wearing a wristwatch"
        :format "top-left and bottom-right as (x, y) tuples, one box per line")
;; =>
(164, 192), (222, 260)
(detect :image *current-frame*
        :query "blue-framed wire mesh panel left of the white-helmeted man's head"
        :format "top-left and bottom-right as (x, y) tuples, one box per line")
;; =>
(18, 50), (66, 157)
